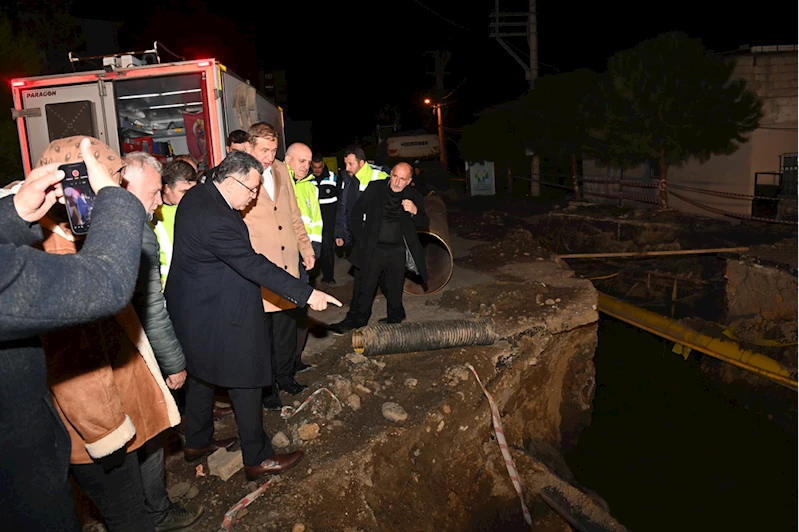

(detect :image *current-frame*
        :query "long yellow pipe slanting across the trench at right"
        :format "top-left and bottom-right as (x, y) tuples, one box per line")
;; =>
(599, 292), (799, 392)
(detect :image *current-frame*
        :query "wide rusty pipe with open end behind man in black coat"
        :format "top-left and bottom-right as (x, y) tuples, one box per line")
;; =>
(403, 192), (455, 296)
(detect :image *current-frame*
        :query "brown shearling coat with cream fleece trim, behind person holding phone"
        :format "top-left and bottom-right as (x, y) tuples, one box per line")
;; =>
(41, 220), (180, 464)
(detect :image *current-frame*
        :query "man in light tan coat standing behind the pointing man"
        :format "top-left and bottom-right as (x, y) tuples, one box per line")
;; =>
(242, 122), (316, 409)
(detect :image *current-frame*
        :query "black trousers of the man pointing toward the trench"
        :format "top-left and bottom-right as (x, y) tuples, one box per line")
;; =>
(186, 375), (275, 466)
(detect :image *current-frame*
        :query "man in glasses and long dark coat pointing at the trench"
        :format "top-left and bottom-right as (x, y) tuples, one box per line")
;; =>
(164, 151), (341, 480)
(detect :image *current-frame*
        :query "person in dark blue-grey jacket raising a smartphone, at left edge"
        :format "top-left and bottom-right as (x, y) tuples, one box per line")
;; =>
(0, 138), (145, 531)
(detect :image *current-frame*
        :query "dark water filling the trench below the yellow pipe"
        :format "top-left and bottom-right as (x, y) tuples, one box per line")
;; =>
(566, 315), (799, 532)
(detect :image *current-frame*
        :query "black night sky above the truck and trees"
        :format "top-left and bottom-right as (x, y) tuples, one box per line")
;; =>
(73, 0), (795, 150)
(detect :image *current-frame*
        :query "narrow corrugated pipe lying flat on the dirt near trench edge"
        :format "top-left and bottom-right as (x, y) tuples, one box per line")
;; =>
(352, 318), (498, 355)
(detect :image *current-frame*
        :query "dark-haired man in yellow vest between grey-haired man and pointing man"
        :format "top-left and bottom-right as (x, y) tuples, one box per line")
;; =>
(153, 160), (197, 290)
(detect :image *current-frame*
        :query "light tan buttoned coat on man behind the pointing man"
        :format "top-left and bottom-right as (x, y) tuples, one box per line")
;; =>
(242, 160), (314, 312)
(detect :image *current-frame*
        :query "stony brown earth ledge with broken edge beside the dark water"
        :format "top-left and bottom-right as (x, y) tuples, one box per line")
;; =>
(142, 238), (625, 532)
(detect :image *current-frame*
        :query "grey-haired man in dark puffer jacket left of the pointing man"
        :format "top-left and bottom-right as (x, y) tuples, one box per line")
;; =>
(123, 152), (203, 530)
